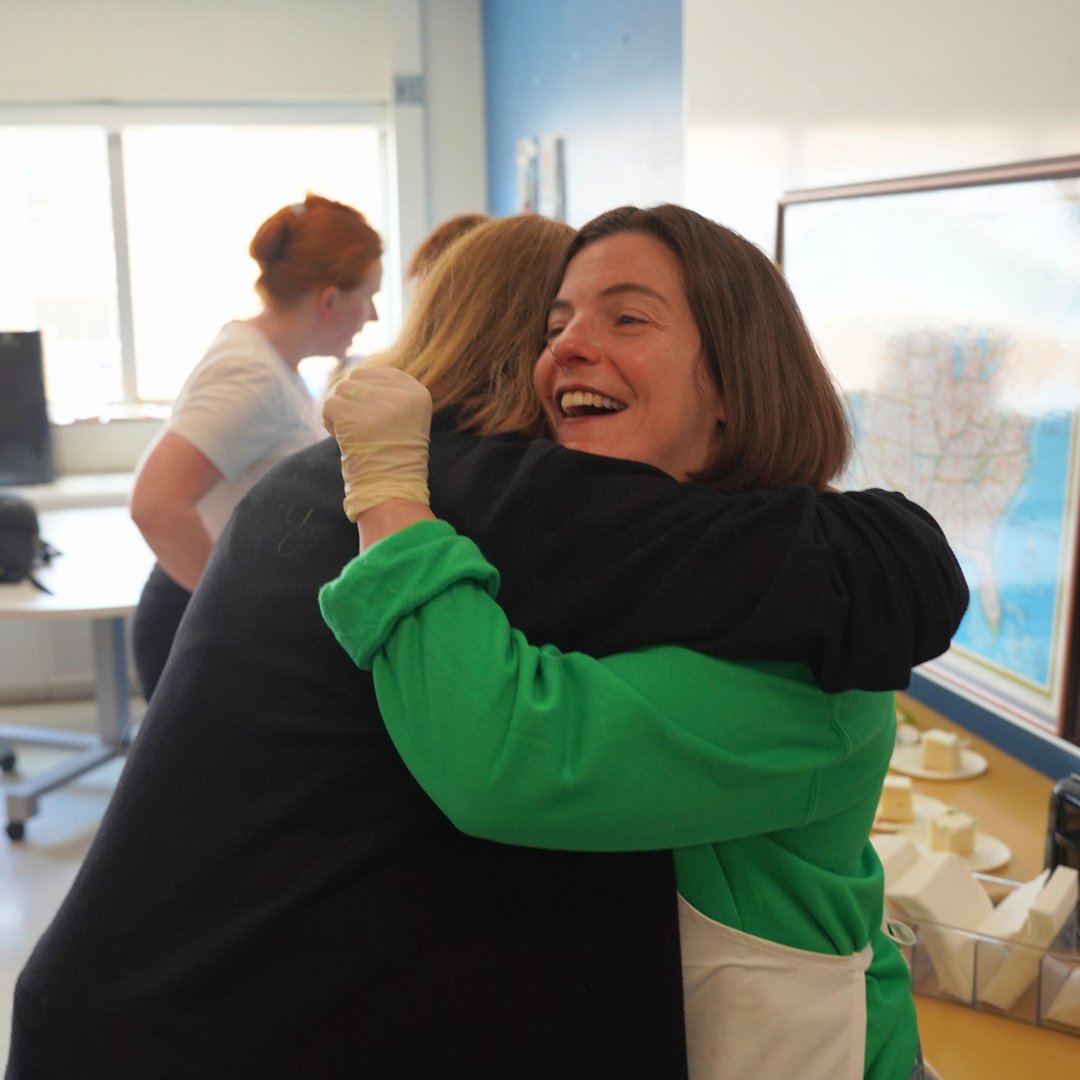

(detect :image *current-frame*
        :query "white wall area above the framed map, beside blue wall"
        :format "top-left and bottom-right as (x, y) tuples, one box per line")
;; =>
(684, 0), (1080, 254)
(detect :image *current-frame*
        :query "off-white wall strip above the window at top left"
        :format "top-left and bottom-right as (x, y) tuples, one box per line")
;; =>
(0, 0), (393, 102)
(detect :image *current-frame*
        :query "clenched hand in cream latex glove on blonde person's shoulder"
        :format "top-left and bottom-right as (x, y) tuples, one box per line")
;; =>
(323, 367), (431, 522)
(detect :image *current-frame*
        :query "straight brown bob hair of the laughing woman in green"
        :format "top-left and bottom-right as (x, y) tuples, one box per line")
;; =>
(565, 204), (852, 491)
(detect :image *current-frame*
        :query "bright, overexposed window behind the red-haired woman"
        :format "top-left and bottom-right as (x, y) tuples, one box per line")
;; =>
(0, 109), (400, 422)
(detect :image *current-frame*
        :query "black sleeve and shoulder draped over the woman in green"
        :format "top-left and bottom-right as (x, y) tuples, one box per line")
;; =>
(431, 415), (968, 691)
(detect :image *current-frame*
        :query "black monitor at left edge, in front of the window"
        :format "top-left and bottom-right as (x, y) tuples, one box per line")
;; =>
(0, 330), (54, 485)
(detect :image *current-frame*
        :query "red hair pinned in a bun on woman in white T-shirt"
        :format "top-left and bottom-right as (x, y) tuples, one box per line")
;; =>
(247, 192), (382, 309)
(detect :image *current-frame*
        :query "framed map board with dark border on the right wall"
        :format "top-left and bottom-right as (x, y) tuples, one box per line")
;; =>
(777, 157), (1080, 740)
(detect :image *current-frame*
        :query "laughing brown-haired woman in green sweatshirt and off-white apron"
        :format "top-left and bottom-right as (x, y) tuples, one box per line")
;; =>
(321, 207), (946, 1080)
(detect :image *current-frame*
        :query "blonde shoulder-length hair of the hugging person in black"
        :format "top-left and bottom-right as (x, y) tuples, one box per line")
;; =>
(370, 214), (573, 435)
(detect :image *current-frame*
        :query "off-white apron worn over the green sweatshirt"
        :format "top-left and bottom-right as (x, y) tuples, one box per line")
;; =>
(678, 896), (872, 1080)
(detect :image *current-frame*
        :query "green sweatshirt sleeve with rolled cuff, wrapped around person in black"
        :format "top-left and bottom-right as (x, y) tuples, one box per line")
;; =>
(320, 522), (876, 851)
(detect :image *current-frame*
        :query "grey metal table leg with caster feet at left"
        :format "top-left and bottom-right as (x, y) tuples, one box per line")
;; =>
(0, 618), (131, 840)
